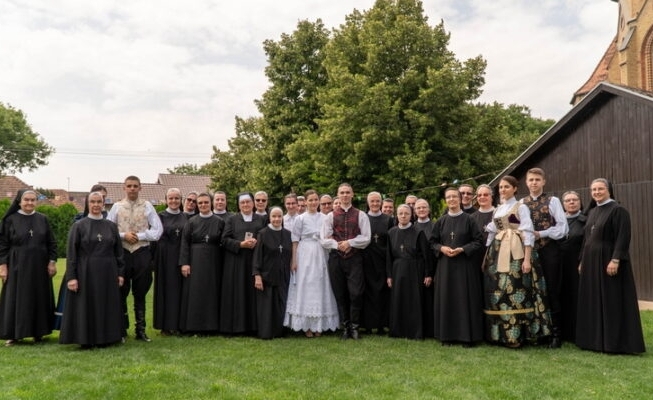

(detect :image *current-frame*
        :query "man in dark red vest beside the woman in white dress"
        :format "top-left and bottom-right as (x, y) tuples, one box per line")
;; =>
(320, 183), (371, 339)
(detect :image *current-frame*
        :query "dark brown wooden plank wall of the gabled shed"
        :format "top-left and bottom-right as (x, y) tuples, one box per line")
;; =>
(504, 96), (653, 301)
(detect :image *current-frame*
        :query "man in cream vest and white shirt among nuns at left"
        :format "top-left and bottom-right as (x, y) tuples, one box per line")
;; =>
(107, 176), (163, 342)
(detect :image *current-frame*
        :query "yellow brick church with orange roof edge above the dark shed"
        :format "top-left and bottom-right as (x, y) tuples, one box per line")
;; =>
(571, 0), (653, 104)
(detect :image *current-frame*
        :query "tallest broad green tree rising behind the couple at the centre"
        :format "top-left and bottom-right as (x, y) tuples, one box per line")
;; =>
(289, 0), (485, 197)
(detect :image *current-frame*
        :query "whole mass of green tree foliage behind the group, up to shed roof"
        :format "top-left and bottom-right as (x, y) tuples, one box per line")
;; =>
(201, 0), (553, 203)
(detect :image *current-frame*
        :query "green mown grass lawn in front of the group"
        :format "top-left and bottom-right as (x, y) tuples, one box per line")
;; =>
(0, 260), (653, 399)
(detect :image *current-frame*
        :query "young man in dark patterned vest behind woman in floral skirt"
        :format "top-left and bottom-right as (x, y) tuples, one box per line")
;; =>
(522, 168), (569, 348)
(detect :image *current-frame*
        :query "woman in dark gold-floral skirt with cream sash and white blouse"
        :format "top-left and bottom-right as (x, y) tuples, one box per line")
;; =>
(484, 175), (551, 348)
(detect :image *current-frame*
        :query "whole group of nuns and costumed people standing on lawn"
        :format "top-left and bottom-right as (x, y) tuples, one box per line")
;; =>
(0, 168), (645, 354)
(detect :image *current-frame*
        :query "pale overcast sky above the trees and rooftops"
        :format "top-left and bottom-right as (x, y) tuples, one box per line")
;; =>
(0, 0), (618, 191)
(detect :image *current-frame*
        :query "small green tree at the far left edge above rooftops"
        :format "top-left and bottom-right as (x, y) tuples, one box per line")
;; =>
(0, 102), (54, 174)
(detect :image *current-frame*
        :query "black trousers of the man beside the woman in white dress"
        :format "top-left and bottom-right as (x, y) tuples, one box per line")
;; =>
(329, 251), (365, 326)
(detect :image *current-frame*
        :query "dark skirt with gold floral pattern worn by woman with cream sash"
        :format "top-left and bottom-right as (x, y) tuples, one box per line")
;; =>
(483, 240), (551, 347)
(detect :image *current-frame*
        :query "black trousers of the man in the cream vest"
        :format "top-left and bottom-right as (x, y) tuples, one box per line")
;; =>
(120, 246), (152, 331)
